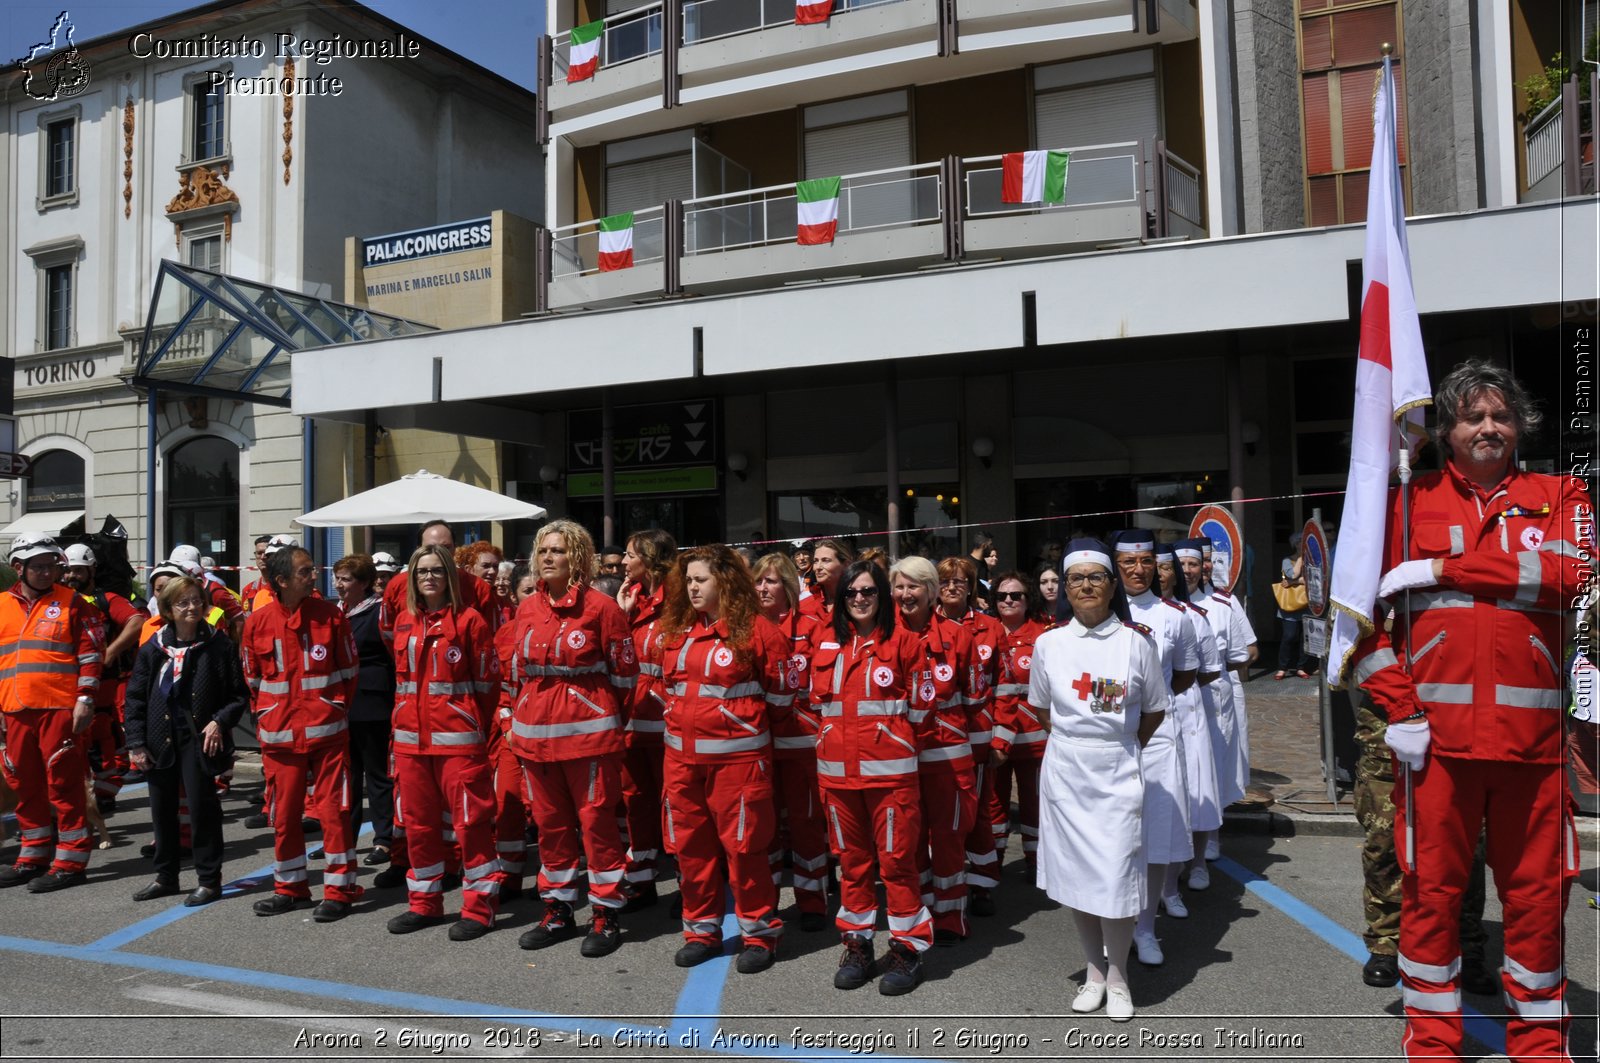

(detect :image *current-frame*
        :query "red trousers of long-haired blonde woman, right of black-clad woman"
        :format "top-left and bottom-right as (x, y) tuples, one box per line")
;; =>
(395, 754), (499, 927)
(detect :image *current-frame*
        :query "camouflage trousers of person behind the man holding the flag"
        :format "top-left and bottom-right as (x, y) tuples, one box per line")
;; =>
(1355, 693), (1485, 959)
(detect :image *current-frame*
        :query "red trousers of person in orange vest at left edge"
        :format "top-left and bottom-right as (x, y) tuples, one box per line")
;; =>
(3, 709), (90, 874)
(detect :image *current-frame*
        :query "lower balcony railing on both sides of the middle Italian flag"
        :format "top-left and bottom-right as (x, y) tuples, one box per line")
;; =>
(683, 162), (944, 255)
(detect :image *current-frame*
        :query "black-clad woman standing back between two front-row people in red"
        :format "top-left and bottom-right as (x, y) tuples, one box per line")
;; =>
(333, 554), (395, 866)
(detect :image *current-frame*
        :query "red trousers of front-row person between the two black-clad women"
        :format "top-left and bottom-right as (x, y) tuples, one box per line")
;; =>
(261, 735), (362, 901)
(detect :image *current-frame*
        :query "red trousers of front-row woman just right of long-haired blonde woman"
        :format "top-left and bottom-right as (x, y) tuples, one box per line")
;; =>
(522, 754), (627, 908)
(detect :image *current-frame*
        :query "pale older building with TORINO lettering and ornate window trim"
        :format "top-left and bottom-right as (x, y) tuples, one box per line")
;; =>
(0, 0), (542, 582)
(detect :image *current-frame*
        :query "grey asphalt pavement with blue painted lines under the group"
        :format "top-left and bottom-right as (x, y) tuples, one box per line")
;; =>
(0, 771), (1600, 1060)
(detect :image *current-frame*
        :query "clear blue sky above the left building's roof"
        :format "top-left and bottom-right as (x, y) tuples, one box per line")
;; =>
(0, 0), (544, 90)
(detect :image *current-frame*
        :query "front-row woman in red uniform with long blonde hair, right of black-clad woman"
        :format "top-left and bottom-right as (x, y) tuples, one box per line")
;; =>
(389, 546), (499, 941)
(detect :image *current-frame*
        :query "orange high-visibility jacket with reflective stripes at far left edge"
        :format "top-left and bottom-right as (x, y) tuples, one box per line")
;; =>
(0, 583), (104, 712)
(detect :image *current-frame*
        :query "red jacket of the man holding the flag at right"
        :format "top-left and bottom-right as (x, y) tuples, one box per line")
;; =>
(1352, 464), (1594, 764)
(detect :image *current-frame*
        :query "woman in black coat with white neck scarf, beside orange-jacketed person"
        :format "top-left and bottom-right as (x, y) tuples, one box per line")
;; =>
(125, 576), (250, 908)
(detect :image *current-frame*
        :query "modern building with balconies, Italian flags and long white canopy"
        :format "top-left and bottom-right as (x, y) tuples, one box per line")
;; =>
(294, 0), (1595, 624)
